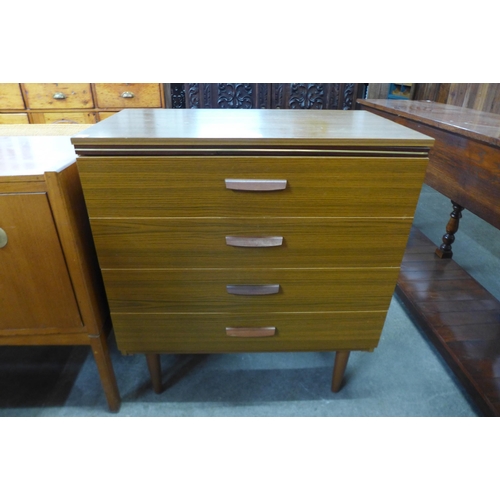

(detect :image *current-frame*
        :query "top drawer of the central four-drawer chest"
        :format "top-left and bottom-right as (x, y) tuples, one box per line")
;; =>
(77, 156), (427, 217)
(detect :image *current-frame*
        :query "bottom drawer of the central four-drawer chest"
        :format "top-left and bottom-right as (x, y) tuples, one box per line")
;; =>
(112, 312), (386, 354)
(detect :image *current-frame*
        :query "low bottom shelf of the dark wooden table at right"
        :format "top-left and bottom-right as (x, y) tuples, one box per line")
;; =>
(396, 229), (500, 416)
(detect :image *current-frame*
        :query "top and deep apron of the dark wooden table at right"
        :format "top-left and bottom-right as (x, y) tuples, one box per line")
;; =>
(360, 99), (500, 228)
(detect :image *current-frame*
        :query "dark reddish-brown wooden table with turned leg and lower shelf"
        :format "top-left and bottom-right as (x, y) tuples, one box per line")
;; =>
(358, 99), (500, 416)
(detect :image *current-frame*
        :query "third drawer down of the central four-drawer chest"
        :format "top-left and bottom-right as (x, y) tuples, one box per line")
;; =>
(102, 270), (399, 313)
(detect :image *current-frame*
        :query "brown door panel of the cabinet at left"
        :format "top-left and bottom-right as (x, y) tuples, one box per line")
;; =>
(0, 193), (82, 335)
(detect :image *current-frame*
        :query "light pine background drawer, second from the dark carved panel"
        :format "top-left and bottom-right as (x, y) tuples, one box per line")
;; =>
(23, 83), (94, 109)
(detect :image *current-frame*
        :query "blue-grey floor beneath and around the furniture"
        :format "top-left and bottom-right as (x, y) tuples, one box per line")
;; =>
(0, 186), (500, 417)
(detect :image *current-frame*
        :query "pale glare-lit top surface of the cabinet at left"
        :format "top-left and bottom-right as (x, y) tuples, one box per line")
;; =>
(0, 136), (76, 178)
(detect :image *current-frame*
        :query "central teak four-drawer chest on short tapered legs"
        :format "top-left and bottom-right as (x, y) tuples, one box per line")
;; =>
(72, 109), (433, 391)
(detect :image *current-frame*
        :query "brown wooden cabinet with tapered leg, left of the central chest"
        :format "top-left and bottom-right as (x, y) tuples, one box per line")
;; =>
(0, 135), (120, 411)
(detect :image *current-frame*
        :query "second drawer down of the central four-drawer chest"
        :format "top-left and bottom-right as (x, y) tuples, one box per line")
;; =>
(91, 217), (412, 269)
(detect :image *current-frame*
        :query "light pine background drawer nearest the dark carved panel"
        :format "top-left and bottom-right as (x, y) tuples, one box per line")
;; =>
(94, 83), (162, 109)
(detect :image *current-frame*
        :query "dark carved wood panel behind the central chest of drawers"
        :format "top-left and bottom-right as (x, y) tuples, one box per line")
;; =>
(167, 83), (366, 109)
